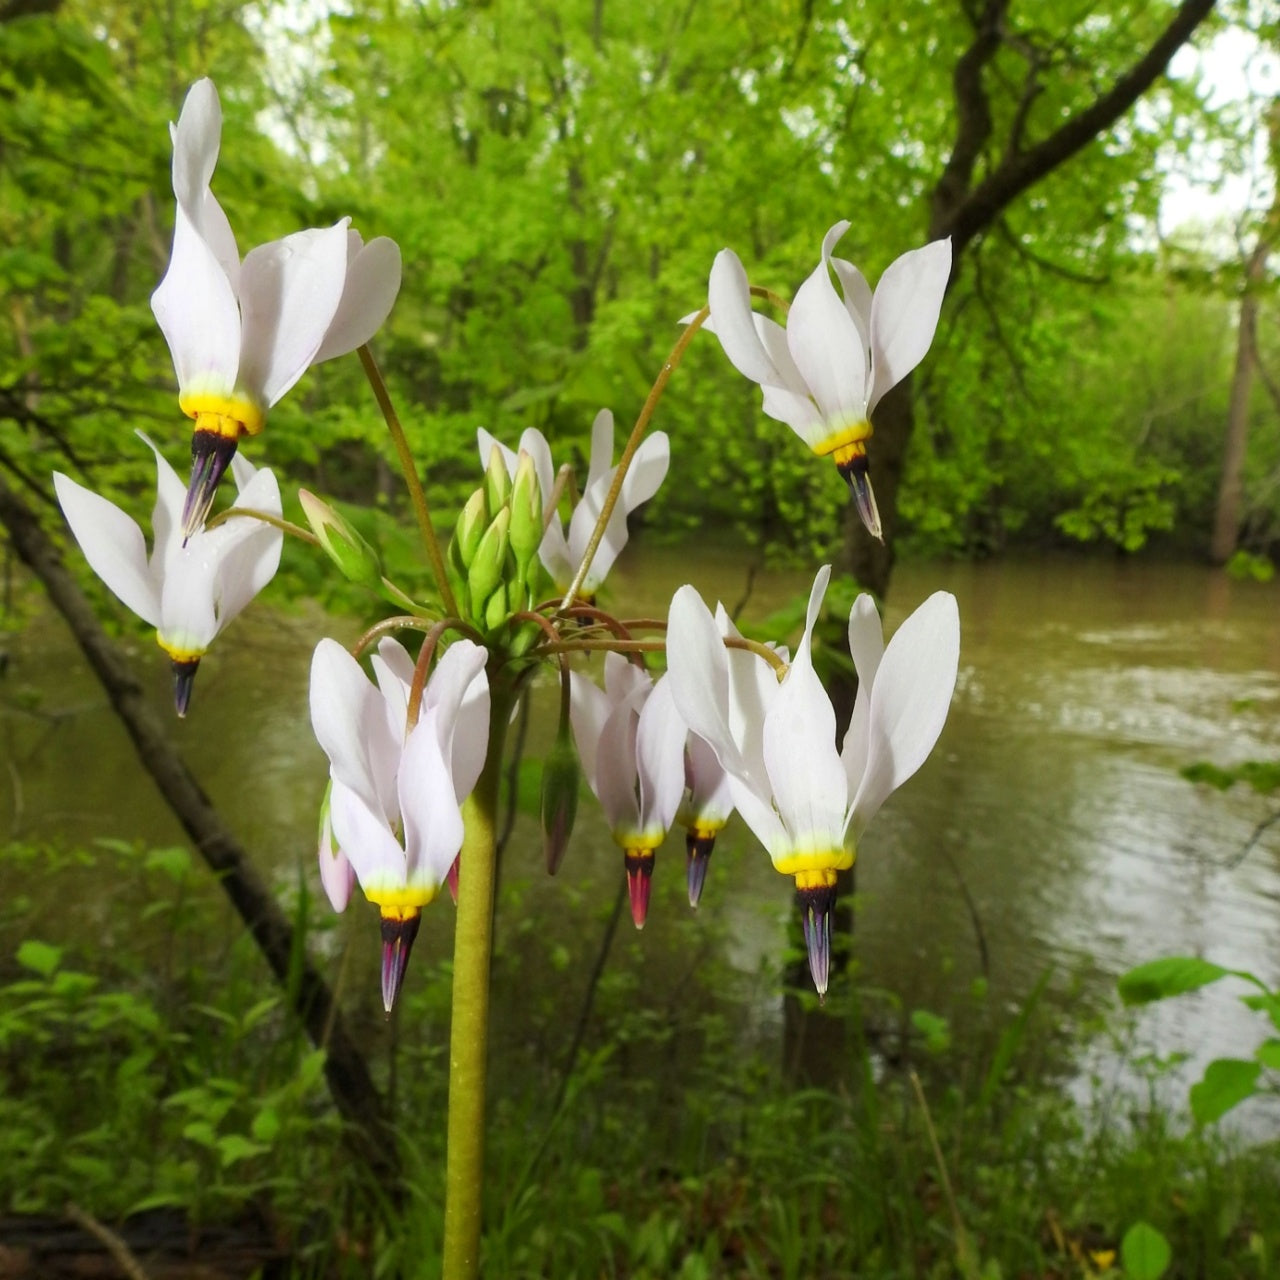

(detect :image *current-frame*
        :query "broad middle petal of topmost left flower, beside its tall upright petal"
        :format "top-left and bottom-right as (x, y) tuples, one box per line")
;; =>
(241, 218), (348, 407)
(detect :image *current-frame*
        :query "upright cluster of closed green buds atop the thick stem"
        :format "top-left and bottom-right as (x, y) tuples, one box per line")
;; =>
(447, 448), (548, 643)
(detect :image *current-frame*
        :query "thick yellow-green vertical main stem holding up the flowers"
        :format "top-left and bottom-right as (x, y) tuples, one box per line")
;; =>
(444, 672), (513, 1280)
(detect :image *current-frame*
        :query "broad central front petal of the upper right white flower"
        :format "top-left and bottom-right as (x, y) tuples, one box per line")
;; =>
(787, 250), (867, 421)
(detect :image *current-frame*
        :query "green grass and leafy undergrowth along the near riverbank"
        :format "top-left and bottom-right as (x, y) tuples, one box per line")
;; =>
(0, 845), (1280, 1280)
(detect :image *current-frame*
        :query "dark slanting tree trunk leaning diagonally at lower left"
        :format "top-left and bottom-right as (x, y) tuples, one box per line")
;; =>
(0, 475), (398, 1178)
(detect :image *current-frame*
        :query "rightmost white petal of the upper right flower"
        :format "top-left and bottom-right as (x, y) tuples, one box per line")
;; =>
(868, 239), (951, 412)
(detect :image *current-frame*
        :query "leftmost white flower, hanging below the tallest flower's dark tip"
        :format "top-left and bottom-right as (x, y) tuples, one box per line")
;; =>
(54, 433), (284, 716)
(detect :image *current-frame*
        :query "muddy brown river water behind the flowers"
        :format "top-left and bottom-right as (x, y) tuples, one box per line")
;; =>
(0, 549), (1280, 1121)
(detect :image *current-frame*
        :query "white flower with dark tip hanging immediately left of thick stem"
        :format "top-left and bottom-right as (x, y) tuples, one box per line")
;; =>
(311, 639), (489, 1012)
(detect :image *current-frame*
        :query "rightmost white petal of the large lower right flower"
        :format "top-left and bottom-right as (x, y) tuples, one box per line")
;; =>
(851, 591), (960, 840)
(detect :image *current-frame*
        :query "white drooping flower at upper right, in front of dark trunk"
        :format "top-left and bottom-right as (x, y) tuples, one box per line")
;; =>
(705, 221), (951, 538)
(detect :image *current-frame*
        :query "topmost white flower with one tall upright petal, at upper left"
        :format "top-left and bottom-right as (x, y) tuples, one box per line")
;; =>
(151, 79), (401, 536)
